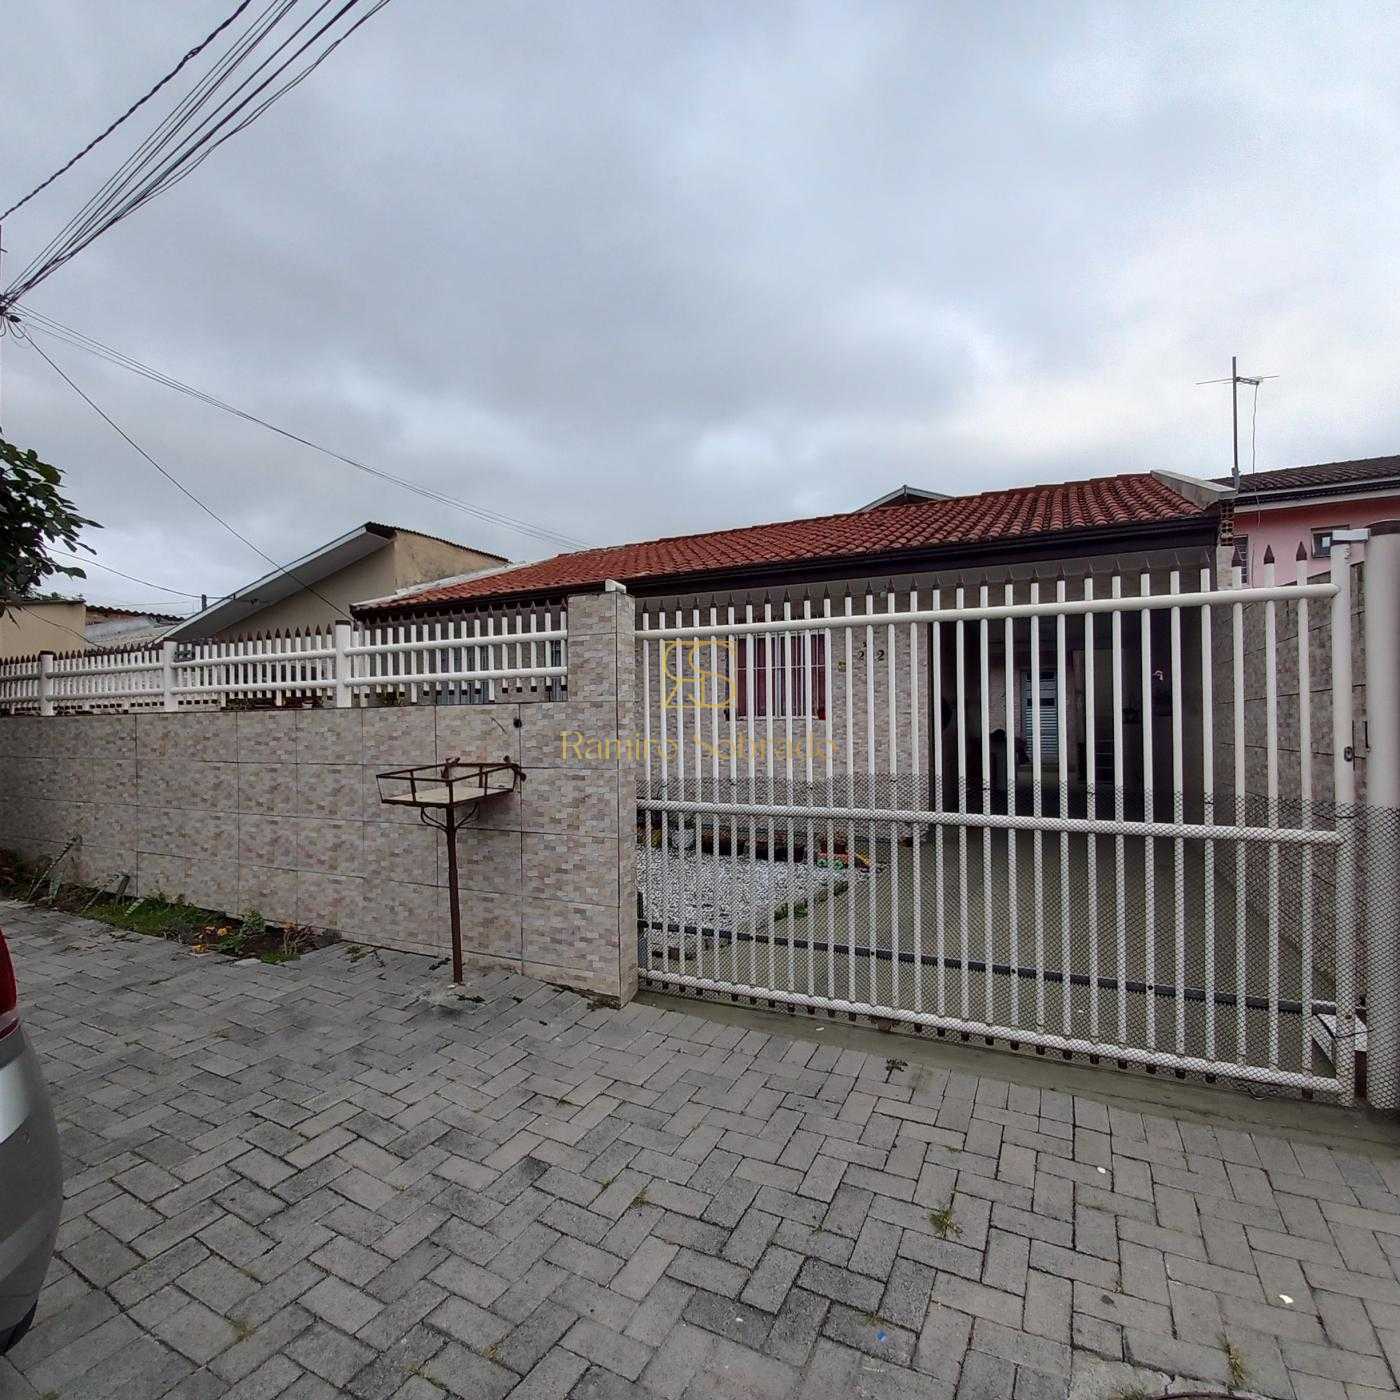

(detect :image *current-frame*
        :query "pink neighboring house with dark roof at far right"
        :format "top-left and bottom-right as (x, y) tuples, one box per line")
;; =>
(1218, 456), (1400, 581)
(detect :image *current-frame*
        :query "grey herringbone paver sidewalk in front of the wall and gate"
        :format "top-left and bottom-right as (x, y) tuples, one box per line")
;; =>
(0, 906), (1400, 1400)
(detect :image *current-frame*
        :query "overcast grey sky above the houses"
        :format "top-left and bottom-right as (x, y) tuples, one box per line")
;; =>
(0, 0), (1400, 613)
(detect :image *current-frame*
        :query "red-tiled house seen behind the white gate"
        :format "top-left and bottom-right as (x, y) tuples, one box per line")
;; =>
(354, 472), (1231, 794)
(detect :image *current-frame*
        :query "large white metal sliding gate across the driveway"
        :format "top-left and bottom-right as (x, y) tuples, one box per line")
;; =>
(637, 552), (1357, 1102)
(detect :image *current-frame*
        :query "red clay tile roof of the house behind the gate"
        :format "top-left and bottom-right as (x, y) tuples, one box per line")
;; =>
(357, 473), (1214, 612)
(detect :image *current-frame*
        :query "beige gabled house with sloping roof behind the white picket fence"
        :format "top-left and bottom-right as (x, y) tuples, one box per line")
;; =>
(167, 521), (507, 641)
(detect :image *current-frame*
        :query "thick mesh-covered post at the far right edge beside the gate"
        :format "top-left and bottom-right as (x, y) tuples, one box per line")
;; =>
(1365, 521), (1400, 1112)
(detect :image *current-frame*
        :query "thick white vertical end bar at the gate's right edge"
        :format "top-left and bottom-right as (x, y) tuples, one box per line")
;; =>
(1331, 543), (1355, 1106)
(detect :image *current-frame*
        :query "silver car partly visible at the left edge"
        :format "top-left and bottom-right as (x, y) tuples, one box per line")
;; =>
(0, 932), (63, 1352)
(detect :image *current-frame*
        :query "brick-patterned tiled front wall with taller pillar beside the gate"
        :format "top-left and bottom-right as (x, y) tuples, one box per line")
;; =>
(0, 594), (636, 1001)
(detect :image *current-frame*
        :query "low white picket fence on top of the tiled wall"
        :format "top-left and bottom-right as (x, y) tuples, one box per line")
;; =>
(0, 606), (568, 715)
